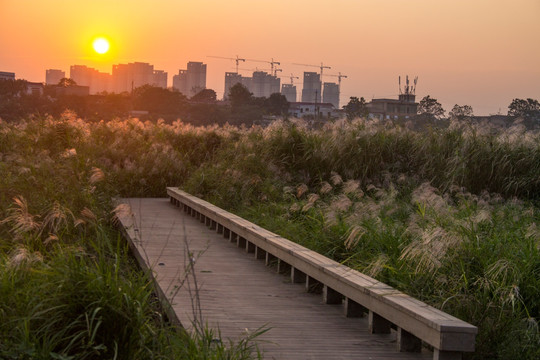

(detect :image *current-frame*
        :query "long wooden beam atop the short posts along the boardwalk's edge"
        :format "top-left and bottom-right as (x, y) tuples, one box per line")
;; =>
(168, 188), (477, 351)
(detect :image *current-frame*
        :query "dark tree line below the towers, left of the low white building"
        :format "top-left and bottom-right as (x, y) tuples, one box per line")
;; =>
(0, 78), (289, 125)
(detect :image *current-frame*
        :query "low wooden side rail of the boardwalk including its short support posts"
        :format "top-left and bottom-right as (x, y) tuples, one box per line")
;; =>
(167, 187), (478, 360)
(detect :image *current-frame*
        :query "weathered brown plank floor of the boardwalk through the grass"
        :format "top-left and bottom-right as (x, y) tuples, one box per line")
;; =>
(119, 198), (433, 360)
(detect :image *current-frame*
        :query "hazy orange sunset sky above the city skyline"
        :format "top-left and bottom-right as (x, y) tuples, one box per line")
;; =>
(0, 0), (540, 115)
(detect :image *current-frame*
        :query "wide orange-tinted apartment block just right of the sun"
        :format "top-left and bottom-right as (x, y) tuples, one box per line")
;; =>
(112, 62), (167, 93)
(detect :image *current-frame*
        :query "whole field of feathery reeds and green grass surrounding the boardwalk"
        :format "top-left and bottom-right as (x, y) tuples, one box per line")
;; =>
(0, 112), (540, 359)
